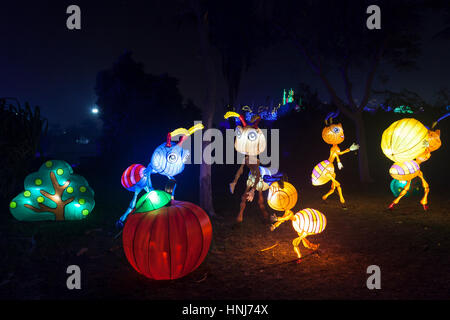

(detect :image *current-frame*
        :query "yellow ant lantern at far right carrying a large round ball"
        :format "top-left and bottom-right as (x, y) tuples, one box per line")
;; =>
(381, 113), (450, 210)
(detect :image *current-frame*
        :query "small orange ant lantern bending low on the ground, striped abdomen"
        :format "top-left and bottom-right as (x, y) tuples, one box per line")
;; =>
(264, 176), (327, 259)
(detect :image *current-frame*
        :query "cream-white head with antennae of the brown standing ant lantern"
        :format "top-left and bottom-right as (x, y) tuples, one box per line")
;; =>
(224, 111), (266, 156)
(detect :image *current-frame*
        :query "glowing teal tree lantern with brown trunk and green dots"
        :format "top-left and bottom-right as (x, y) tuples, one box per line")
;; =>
(9, 160), (95, 221)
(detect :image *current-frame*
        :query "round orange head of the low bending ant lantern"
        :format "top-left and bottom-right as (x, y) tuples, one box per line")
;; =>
(267, 181), (298, 211)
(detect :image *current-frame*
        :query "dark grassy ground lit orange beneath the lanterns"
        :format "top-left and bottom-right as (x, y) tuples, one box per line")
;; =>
(0, 185), (450, 300)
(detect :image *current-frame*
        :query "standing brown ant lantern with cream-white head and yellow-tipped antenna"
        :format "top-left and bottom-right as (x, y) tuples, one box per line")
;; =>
(224, 111), (271, 222)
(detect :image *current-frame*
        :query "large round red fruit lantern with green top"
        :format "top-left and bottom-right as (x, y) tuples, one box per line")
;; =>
(123, 190), (212, 280)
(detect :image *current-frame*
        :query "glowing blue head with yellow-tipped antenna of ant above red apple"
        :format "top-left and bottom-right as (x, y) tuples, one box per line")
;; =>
(150, 123), (204, 177)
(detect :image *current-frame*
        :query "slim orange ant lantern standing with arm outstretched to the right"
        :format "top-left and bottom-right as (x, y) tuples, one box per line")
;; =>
(311, 112), (359, 209)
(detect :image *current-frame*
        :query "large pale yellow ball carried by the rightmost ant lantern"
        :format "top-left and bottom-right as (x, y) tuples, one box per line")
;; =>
(381, 118), (429, 163)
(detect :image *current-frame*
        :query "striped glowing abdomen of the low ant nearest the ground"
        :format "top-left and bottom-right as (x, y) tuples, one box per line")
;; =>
(292, 208), (327, 236)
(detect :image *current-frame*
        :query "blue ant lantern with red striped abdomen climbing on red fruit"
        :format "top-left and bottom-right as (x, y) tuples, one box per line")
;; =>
(116, 123), (204, 228)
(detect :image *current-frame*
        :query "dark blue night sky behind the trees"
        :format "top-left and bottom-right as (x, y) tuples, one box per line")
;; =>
(0, 1), (450, 126)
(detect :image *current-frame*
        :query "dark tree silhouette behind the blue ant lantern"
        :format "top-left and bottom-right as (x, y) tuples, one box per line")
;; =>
(95, 52), (200, 161)
